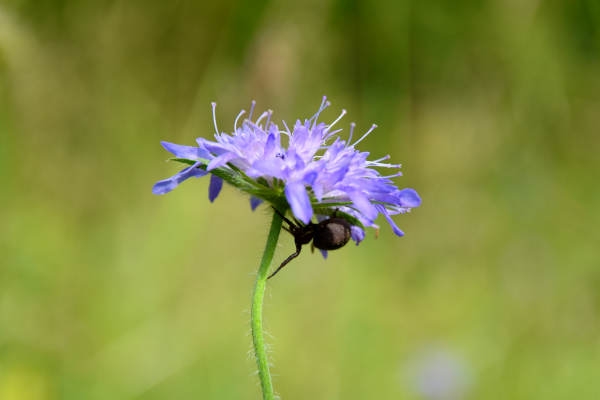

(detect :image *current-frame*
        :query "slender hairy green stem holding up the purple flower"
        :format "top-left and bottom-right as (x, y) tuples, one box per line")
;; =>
(251, 212), (282, 400)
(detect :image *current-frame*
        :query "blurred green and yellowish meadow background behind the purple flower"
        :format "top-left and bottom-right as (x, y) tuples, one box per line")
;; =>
(0, 0), (600, 400)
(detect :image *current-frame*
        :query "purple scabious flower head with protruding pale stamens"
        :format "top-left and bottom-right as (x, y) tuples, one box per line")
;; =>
(152, 97), (421, 244)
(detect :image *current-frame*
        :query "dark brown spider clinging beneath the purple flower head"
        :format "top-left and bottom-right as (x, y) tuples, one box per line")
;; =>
(267, 208), (350, 279)
